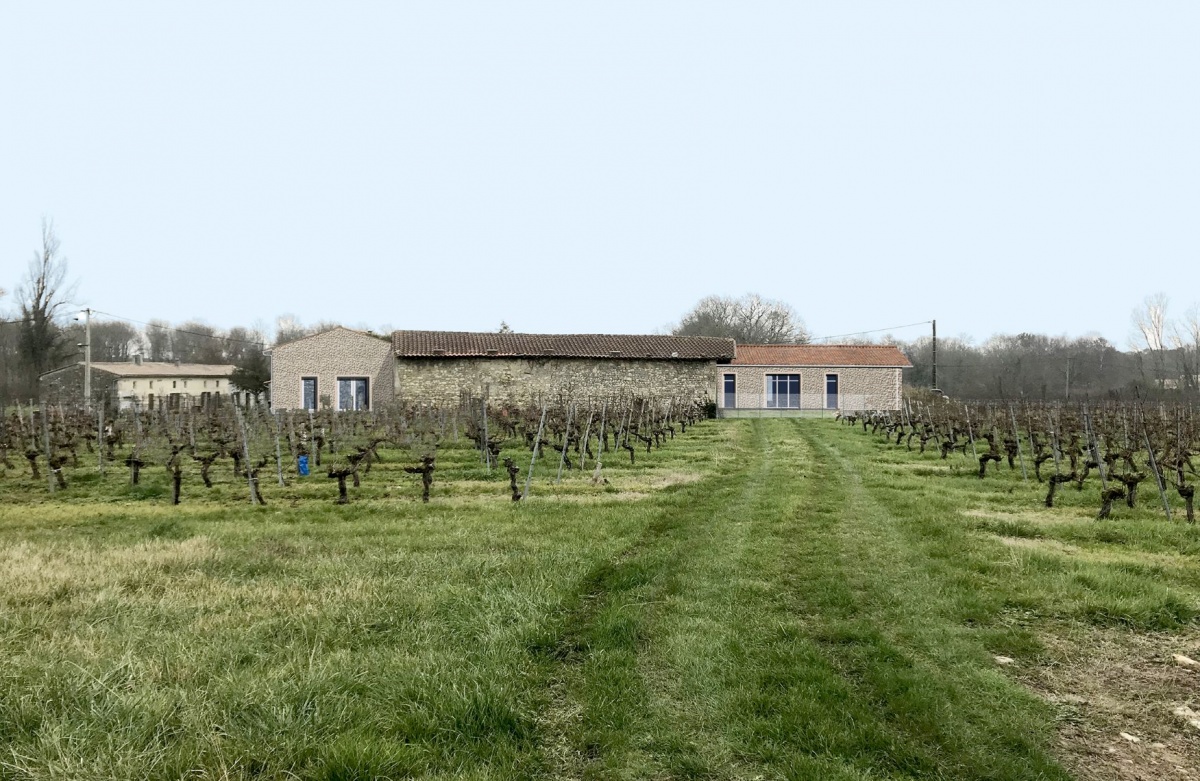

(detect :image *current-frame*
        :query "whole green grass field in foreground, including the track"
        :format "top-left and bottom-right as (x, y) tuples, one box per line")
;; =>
(0, 419), (1200, 780)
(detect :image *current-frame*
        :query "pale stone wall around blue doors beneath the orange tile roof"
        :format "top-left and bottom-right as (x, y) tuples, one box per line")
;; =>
(716, 366), (904, 409)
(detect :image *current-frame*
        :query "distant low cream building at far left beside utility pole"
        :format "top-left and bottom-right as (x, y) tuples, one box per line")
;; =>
(38, 355), (246, 409)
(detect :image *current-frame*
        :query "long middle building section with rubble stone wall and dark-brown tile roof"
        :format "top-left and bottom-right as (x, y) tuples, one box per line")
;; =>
(392, 331), (734, 403)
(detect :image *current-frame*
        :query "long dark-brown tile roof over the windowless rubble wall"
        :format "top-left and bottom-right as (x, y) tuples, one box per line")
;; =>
(391, 331), (734, 361)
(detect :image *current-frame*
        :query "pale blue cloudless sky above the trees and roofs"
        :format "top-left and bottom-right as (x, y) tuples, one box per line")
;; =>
(0, 0), (1200, 347)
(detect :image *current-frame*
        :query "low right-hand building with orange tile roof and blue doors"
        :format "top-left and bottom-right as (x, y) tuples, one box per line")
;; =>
(718, 344), (912, 417)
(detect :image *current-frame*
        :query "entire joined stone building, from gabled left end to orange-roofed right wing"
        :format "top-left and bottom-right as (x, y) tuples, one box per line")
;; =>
(271, 328), (912, 415)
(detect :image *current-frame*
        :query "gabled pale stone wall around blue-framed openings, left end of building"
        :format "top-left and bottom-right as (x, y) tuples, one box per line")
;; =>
(271, 328), (395, 409)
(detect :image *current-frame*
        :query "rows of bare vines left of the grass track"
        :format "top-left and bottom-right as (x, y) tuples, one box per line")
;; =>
(0, 396), (706, 505)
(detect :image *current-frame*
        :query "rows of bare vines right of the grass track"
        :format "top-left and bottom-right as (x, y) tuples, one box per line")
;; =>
(842, 393), (1200, 523)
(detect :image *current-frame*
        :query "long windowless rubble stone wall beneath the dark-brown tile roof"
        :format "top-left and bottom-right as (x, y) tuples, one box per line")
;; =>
(396, 358), (716, 403)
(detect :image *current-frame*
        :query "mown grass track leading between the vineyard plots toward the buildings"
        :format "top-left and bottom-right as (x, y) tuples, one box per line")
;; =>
(535, 420), (1066, 780)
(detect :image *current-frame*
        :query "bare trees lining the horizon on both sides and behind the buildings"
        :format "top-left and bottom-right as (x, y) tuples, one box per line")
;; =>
(7, 223), (1200, 408)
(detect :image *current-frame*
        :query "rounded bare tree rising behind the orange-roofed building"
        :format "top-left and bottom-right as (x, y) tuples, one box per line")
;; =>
(671, 293), (809, 344)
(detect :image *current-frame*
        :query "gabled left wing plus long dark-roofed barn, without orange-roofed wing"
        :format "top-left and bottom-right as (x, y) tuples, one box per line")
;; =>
(271, 328), (734, 409)
